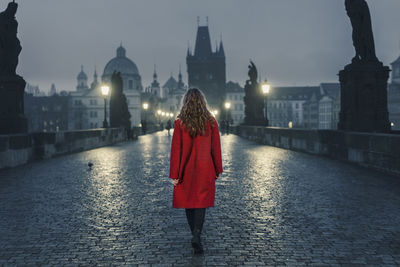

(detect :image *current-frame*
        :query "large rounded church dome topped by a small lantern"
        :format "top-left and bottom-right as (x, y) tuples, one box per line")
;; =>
(103, 45), (139, 76)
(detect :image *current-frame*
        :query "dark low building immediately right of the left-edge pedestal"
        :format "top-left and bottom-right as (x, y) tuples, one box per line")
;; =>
(24, 93), (70, 132)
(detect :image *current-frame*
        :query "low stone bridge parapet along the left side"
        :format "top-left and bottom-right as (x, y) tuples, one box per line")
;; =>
(0, 128), (126, 169)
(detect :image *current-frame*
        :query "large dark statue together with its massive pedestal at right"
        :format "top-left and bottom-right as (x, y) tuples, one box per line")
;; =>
(338, 0), (390, 132)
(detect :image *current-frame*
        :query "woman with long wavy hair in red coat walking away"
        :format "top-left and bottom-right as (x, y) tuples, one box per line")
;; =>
(169, 88), (222, 254)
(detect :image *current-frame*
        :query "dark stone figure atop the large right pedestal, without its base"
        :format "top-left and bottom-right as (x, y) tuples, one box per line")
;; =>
(345, 0), (378, 62)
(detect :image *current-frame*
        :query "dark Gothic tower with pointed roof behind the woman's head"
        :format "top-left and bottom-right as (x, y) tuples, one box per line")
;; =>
(186, 22), (226, 108)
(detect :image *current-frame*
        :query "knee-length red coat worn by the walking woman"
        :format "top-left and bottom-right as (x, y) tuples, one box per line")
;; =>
(169, 119), (222, 208)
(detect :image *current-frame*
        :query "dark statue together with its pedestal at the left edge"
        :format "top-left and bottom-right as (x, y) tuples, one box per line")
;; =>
(0, 1), (28, 134)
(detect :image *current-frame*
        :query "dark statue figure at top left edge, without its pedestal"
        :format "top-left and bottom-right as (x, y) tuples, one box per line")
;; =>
(0, 2), (22, 77)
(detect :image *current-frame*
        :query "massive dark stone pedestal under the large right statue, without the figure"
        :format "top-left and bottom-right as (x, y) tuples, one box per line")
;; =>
(338, 62), (390, 133)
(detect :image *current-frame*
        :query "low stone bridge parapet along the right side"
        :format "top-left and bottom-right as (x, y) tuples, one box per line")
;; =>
(234, 126), (400, 176)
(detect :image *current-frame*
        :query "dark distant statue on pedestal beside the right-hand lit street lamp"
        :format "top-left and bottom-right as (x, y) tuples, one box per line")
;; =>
(244, 60), (267, 126)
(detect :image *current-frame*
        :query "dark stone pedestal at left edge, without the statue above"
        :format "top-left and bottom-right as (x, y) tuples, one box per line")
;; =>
(0, 75), (28, 134)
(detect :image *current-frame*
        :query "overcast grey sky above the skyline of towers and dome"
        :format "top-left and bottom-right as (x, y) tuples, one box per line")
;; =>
(11, 0), (400, 94)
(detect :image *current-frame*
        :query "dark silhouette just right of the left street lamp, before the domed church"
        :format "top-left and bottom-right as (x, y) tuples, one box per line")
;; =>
(110, 71), (131, 131)
